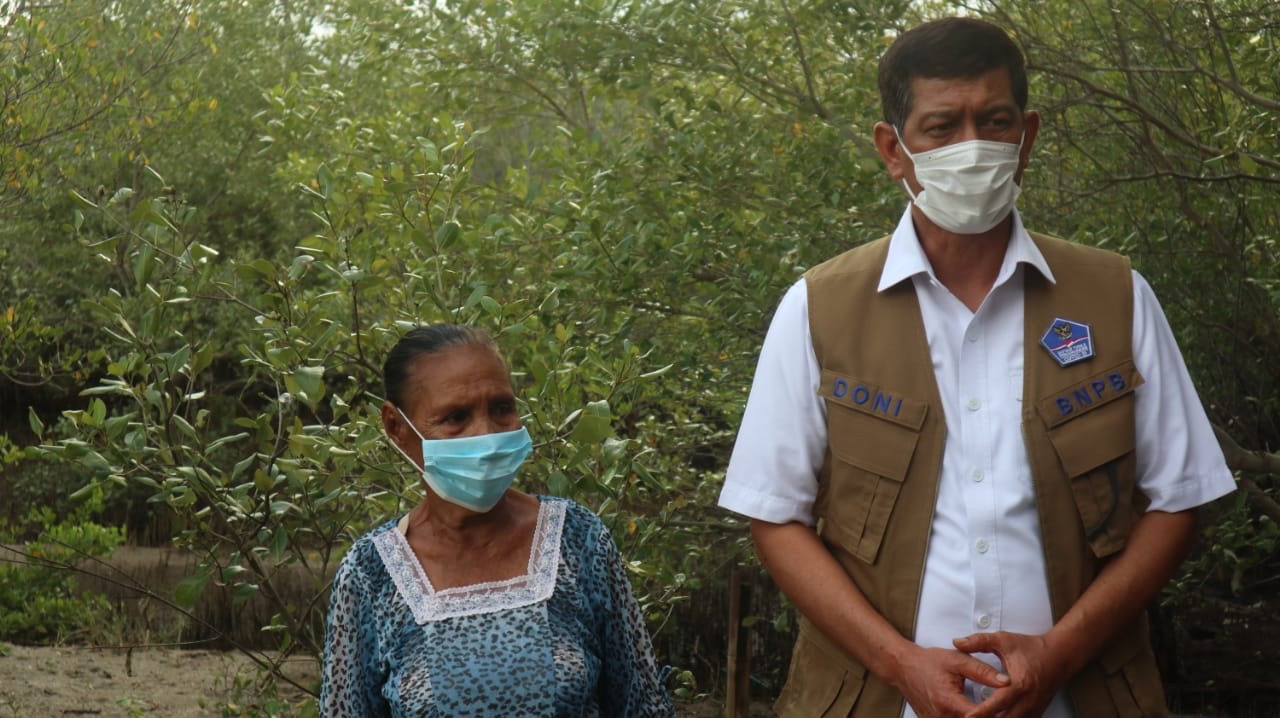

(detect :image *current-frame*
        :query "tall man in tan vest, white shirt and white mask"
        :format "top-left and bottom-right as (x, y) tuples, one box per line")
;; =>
(721, 18), (1234, 718)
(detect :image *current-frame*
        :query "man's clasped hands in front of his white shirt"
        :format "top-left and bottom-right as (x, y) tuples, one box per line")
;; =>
(900, 631), (1066, 718)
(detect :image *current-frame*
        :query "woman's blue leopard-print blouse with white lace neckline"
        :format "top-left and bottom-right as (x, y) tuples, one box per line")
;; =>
(320, 497), (675, 718)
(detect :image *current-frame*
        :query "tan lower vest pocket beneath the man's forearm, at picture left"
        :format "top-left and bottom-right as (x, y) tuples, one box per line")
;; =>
(773, 619), (867, 718)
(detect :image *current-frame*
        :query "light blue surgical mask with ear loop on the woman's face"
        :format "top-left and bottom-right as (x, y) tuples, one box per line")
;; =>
(392, 408), (534, 513)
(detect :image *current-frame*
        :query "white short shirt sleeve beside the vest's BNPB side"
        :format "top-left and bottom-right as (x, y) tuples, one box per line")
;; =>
(1133, 271), (1235, 512)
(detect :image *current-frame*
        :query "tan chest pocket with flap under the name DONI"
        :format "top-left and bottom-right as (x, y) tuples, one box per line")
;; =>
(819, 402), (920, 563)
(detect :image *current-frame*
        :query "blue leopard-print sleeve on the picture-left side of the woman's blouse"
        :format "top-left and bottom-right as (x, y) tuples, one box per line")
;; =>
(320, 550), (390, 718)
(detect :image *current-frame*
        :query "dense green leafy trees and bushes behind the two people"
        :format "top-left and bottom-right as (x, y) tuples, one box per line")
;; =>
(0, 0), (1280, 706)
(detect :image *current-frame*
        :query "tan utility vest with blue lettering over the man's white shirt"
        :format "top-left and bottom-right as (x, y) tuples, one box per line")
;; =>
(774, 234), (1167, 718)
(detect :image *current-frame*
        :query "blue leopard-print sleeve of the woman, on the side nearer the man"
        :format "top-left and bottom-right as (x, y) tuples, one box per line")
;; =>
(589, 526), (676, 718)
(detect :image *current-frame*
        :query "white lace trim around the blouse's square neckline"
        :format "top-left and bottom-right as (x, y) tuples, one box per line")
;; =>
(374, 500), (564, 625)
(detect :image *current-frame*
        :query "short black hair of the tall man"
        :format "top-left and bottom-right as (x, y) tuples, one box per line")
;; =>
(878, 18), (1027, 129)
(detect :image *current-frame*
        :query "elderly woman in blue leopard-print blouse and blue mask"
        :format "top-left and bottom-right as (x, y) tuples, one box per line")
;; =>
(320, 325), (673, 717)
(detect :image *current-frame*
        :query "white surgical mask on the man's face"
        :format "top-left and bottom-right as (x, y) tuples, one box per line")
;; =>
(893, 127), (1023, 234)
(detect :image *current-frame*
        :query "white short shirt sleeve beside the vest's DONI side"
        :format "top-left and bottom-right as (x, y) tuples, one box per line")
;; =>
(719, 278), (827, 526)
